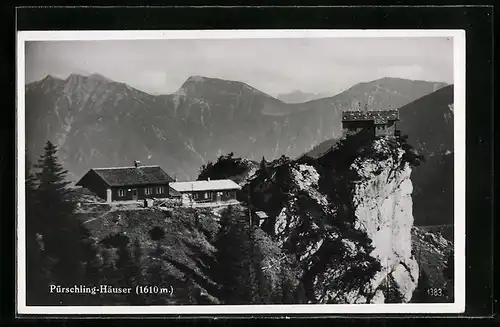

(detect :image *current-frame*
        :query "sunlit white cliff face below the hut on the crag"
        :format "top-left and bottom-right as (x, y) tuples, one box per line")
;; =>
(353, 140), (419, 303)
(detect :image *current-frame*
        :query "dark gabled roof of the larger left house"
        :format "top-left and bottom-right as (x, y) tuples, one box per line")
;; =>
(76, 166), (174, 186)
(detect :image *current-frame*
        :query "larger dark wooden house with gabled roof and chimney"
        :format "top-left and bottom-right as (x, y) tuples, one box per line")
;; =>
(76, 161), (174, 202)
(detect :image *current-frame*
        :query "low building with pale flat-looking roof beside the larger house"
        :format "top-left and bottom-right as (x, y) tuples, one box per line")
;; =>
(170, 179), (241, 206)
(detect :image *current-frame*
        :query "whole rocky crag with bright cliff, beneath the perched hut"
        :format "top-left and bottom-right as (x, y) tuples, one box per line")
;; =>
(240, 137), (419, 303)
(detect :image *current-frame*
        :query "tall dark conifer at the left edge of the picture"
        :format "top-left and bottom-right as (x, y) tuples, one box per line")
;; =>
(36, 141), (89, 303)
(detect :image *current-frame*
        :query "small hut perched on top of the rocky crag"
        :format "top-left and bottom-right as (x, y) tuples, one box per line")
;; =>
(342, 110), (399, 136)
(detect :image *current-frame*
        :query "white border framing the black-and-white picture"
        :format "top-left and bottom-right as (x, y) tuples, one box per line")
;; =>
(16, 30), (465, 315)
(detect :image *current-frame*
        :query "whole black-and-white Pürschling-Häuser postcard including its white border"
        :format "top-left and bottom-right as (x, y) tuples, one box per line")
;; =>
(17, 30), (465, 314)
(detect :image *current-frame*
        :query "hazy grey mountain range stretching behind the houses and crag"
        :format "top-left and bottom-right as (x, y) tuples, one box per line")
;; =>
(25, 74), (452, 184)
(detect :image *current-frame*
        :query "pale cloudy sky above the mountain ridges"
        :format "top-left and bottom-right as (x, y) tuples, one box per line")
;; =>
(25, 37), (453, 96)
